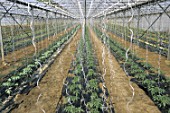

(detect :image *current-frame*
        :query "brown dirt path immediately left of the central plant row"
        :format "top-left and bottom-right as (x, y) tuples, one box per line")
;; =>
(12, 30), (81, 113)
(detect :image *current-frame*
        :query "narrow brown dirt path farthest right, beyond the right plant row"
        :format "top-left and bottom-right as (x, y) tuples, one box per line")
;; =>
(108, 32), (170, 77)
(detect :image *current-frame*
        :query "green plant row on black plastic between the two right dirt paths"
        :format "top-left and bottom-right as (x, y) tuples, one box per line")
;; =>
(95, 29), (170, 113)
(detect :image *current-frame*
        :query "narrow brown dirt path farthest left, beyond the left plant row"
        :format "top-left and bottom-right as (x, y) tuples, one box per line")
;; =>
(0, 28), (75, 78)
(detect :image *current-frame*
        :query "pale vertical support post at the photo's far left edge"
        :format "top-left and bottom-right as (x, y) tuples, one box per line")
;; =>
(0, 19), (6, 65)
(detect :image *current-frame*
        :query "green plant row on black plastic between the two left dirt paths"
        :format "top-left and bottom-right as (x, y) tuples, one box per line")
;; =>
(0, 26), (79, 112)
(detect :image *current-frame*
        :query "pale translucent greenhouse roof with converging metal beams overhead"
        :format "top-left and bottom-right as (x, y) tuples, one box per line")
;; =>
(0, 0), (170, 18)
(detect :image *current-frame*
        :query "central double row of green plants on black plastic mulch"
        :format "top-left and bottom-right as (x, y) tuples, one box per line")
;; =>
(57, 26), (114, 113)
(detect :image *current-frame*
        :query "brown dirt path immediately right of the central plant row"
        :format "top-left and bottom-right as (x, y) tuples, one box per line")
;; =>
(90, 27), (160, 113)
